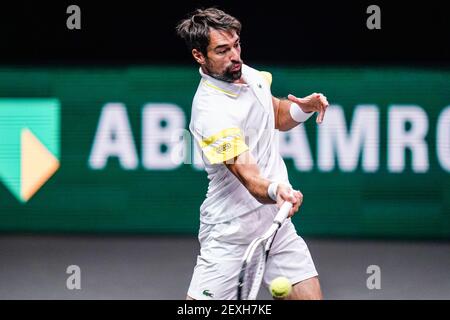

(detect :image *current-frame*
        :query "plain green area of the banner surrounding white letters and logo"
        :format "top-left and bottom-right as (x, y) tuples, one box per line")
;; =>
(0, 66), (450, 238)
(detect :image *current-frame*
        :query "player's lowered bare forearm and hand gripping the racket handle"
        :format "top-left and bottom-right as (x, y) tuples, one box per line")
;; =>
(224, 150), (303, 216)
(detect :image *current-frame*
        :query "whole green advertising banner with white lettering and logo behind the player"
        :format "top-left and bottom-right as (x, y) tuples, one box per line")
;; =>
(0, 66), (450, 239)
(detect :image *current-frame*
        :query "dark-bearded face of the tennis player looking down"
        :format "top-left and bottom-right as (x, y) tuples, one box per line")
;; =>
(194, 29), (242, 82)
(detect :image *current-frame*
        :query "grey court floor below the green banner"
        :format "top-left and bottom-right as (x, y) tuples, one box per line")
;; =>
(0, 235), (450, 300)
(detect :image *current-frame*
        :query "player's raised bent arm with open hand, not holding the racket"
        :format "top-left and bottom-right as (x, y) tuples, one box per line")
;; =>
(272, 93), (328, 131)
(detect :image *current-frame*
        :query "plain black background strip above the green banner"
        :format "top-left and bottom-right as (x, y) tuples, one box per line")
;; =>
(0, 0), (450, 67)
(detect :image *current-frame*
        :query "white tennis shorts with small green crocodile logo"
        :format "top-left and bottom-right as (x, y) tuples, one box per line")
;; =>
(188, 205), (317, 300)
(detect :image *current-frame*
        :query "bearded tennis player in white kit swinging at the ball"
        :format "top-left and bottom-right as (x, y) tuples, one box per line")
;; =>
(177, 8), (328, 300)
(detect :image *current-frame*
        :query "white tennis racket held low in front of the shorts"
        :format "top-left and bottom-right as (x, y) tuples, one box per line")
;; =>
(237, 201), (292, 300)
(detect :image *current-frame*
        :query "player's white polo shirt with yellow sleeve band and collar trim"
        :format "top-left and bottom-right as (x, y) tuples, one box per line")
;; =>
(189, 65), (290, 224)
